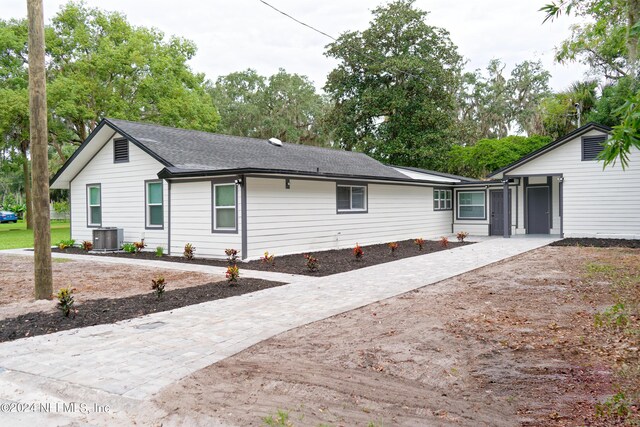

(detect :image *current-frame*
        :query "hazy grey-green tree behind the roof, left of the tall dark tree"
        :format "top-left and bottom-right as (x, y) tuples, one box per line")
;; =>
(209, 69), (328, 145)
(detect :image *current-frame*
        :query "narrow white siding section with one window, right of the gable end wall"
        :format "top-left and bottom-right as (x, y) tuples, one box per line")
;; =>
(171, 179), (242, 258)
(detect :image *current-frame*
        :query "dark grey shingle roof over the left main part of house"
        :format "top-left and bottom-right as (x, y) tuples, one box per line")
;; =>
(106, 119), (407, 180)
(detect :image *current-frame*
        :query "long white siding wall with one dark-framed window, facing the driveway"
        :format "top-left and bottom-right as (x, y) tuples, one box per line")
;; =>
(247, 178), (451, 258)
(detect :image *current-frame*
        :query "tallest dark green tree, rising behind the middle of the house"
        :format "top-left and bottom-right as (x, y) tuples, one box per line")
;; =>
(325, 0), (462, 168)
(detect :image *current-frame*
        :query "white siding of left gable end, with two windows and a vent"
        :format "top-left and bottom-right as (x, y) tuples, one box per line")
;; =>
(69, 135), (168, 251)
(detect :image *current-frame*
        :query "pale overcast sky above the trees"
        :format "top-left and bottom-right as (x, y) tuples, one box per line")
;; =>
(0, 0), (587, 91)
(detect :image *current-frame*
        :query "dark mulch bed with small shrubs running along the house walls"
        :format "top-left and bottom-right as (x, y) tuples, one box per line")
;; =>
(53, 240), (471, 276)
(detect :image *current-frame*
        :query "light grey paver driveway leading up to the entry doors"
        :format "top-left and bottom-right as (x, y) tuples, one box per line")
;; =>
(0, 237), (556, 406)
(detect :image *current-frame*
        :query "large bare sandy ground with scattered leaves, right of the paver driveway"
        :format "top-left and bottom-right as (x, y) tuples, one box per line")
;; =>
(153, 247), (640, 426)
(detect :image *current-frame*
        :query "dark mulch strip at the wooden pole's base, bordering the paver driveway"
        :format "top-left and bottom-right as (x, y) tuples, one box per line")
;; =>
(0, 278), (284, 342)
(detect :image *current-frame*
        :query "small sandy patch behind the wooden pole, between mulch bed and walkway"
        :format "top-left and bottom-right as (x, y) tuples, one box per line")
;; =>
(0, 255), (224, 319)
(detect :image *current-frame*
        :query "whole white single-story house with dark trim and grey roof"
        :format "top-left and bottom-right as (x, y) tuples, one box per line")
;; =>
(51, 119), (640, 259)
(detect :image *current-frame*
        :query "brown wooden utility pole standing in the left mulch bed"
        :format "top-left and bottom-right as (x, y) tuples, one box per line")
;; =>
(27, 0), (53, 299)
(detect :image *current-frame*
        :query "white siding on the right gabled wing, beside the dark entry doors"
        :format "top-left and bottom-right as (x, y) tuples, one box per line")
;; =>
(508, 131), (640, 238)
